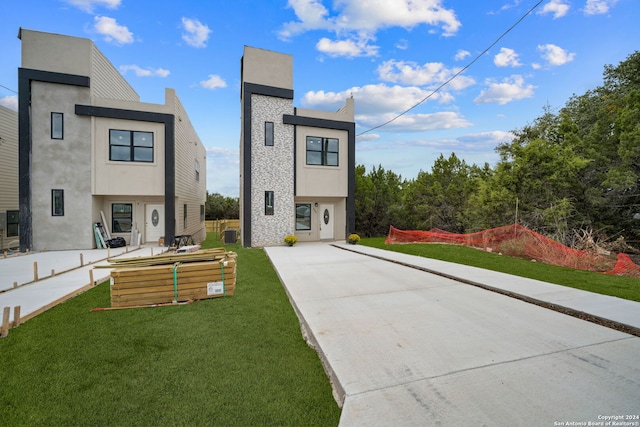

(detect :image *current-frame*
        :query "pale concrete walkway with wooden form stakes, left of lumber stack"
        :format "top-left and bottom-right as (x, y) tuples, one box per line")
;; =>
(0, 246), (166, 324)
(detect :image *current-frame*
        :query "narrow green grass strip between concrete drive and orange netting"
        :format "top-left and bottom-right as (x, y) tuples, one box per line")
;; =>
(360, 237), (640, 301)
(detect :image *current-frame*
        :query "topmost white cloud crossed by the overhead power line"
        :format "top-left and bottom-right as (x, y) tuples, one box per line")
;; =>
(377, 59), (475, 90)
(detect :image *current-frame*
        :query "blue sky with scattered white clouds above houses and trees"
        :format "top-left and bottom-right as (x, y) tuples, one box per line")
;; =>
(0, 0), (640, 197)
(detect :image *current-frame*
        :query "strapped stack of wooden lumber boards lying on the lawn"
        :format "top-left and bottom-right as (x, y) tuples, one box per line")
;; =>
(111, 253), (236, 307)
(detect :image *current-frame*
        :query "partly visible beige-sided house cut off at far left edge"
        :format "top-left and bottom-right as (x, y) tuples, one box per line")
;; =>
(0, 105), (19, 250)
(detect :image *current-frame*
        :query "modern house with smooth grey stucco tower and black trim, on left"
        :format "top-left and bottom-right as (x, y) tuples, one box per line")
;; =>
(18, 29), (206, 251)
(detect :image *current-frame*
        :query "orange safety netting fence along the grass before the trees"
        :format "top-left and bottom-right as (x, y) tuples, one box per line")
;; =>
(385, 224), (640, 278)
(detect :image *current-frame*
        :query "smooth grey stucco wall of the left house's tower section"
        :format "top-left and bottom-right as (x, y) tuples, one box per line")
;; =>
(31, 82), (93, 250)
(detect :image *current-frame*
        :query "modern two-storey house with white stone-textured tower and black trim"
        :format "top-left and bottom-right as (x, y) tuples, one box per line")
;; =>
(240, 46), (355, 247)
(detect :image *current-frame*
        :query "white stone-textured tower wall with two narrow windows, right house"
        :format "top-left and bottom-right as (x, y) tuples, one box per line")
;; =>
(251, 95), (295, 246)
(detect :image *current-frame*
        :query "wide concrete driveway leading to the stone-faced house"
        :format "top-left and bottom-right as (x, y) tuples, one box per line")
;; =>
(265, 243), (640, 426)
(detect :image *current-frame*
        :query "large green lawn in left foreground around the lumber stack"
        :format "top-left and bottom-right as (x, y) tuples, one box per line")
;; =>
(0, 236), (340, 426)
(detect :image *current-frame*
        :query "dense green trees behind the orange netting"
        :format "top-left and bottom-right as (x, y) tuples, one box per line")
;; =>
(355, 51), (640, 249)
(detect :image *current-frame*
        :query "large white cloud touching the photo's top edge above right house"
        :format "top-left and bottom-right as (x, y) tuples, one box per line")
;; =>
(279, 0), (461, 40)
